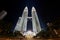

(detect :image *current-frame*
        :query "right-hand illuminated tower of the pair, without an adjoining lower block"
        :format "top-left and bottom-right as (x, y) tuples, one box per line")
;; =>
(31, 7), (41, 33)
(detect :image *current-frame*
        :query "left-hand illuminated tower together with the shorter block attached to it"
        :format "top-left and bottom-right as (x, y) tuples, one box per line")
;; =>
(14, 7), (28, 33)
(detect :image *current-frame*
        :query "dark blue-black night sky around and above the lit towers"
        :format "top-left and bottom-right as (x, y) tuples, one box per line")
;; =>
(0, 0), (60, 29)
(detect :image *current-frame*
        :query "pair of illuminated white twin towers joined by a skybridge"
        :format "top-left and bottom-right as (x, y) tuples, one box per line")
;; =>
(14, 7), (41, 34)
